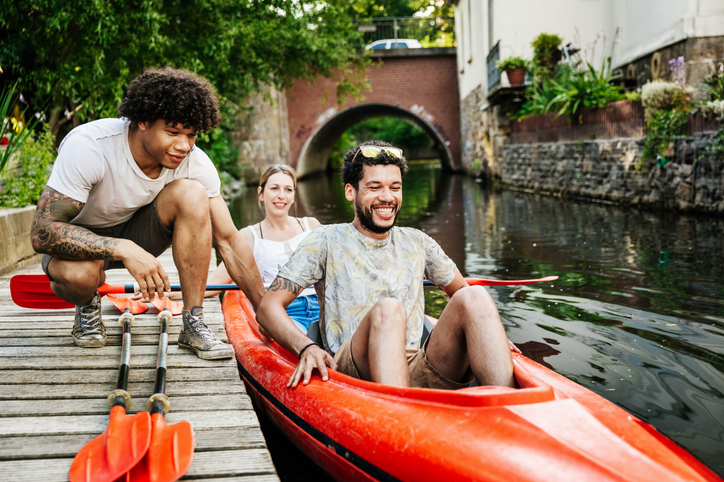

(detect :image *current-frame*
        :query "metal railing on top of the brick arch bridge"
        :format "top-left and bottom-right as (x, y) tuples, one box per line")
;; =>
(354, 17), (455, 47)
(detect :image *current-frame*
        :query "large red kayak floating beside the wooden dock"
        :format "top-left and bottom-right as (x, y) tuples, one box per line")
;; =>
(223, 291), (722, 482)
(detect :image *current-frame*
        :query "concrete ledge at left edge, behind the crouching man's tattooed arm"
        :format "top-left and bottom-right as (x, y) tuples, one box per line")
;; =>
(0, 206), (38, 274)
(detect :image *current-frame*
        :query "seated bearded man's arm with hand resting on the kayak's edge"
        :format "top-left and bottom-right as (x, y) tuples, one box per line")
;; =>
(256, 276), (337, 388)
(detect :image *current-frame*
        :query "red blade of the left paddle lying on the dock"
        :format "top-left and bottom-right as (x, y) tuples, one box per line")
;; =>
(69, 405), (151, 482)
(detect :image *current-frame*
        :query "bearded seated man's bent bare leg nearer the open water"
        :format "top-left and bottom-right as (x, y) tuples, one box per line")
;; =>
(427, 286), (516, 387)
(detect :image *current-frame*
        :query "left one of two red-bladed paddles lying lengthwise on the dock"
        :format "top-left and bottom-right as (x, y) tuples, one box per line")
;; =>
(69, 310), (151, 482)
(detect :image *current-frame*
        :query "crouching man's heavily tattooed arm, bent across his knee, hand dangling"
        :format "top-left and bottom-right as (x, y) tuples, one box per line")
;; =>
(30, 187), (171, 300)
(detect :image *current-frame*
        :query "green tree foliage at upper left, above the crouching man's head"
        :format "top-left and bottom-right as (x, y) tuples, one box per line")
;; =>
(0, 0), (364, 136)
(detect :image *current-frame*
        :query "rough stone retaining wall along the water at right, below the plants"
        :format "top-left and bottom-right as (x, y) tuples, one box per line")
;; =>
(493, 132), (724, 213)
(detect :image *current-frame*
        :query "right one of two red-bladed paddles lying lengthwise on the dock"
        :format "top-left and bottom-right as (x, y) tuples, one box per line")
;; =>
(126, 309), (194, 482)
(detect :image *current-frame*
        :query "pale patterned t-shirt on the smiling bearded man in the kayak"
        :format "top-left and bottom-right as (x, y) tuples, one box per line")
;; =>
(279, 224), (455, 353)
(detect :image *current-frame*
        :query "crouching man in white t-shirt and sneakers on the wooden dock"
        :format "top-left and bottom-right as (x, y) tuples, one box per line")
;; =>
(31, 68), (264, 359)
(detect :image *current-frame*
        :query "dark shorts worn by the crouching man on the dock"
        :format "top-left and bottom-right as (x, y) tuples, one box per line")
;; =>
(40, 199), (173, 280)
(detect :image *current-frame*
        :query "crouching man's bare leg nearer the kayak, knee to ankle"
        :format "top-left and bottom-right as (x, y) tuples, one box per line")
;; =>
(156, 179), (212, 309)
